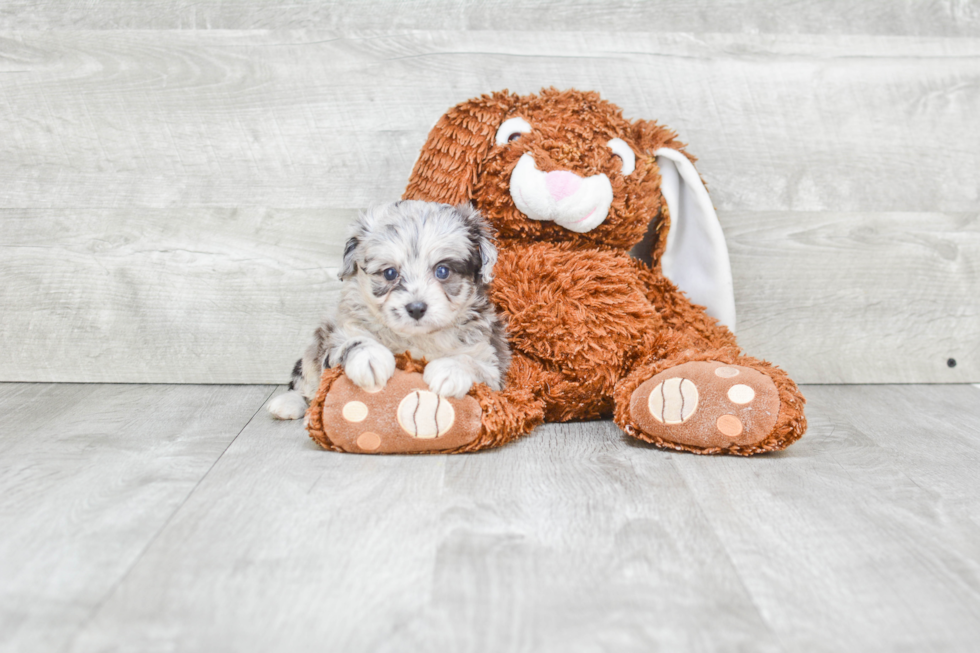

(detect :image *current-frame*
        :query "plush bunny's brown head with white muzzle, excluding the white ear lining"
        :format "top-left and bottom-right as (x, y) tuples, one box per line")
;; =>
(406, 89), (679, 255)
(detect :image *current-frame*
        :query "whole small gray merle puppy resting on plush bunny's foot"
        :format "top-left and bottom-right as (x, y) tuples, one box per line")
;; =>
(269, 201), (510, 419)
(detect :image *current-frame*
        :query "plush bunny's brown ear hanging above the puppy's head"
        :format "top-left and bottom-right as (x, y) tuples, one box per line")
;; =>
(402, 90), (520, 204)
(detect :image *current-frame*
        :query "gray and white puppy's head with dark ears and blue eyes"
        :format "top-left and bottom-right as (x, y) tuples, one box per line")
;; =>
(339, 200), (497, 336)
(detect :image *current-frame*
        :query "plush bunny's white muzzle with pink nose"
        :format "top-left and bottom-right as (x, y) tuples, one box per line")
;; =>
(510, 153), (612, 233)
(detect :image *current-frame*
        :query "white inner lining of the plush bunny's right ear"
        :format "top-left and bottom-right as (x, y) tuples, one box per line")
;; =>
(654, 147), (735, 333)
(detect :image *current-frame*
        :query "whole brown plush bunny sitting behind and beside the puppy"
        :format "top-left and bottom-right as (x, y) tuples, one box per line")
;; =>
(308, 89), (806, 455)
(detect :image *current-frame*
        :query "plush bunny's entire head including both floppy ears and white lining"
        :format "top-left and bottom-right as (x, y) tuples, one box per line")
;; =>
(403, 88), (734, 327)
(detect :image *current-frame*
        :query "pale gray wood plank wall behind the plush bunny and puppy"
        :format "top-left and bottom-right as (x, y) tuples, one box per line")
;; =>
(0, 0), (980, 383)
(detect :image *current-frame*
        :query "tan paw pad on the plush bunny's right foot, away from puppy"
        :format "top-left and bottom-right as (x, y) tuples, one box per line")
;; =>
(630, 361), (779, 449)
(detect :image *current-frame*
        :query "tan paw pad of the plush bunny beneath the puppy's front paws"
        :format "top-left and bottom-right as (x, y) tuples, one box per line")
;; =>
(323, 370), (481, 453)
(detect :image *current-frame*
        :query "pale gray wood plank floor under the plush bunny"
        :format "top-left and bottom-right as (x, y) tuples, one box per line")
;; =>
(0, 384), (980, 652)
